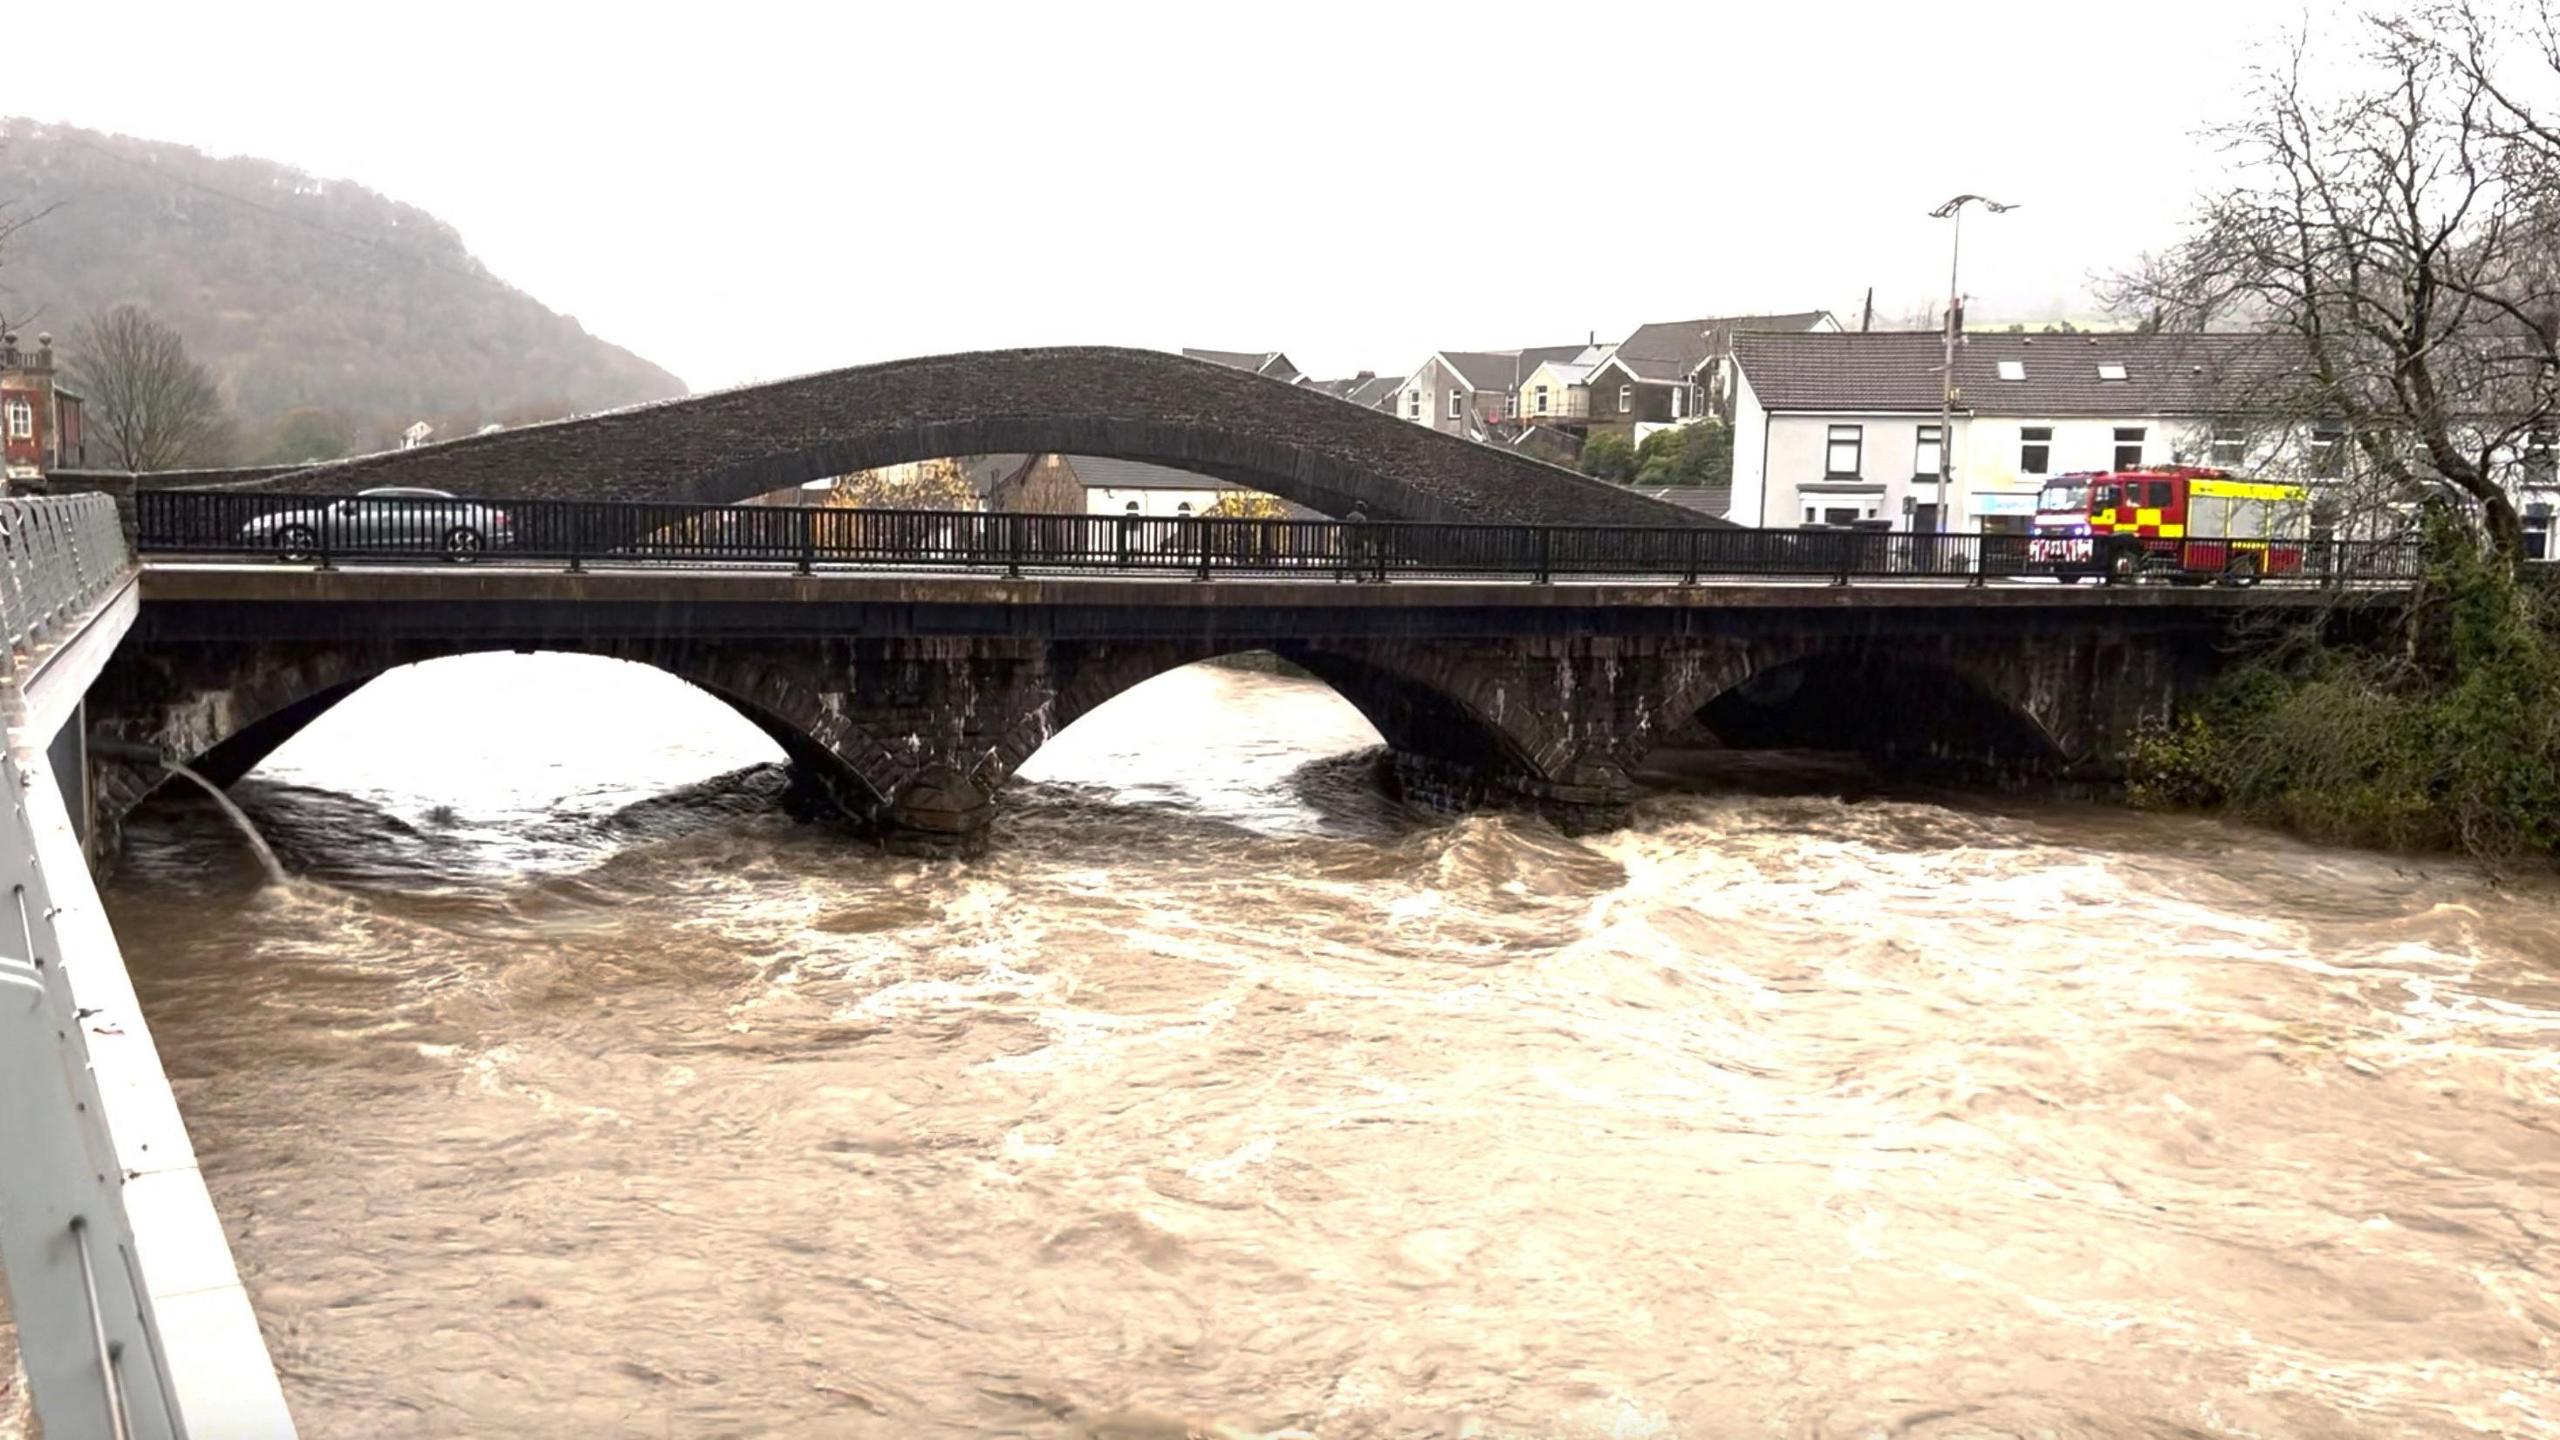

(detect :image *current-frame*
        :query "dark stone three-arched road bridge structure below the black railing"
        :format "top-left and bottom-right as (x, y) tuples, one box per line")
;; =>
(90, 566), (2355, 848)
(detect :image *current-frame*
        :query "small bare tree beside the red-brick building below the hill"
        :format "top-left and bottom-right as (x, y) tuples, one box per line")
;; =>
(72, 305), (230, 469)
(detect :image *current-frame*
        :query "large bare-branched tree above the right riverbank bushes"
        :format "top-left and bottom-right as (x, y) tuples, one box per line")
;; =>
(2112, 11), (2560, 556)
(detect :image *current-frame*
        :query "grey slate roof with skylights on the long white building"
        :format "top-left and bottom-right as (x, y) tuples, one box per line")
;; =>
(1733, 331), (2286, 418)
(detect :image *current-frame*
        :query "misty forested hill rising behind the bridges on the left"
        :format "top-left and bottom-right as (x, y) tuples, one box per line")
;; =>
(0, 120), (684, 461)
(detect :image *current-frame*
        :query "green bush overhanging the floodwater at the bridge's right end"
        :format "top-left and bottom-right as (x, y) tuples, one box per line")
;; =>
(2127, 509), (2560, 858)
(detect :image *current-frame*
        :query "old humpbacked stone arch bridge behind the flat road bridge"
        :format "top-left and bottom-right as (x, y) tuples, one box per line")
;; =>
(215, 348), (1715, 525)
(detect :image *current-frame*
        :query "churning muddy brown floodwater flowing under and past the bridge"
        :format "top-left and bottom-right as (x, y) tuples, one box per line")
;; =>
(5, 656), (2560, 1440)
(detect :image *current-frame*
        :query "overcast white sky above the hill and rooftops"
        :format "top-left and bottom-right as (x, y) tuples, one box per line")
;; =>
(20, 0), (2344, 387)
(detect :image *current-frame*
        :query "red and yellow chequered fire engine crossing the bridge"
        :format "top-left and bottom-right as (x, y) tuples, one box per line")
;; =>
(2028, 466), (2312, 584)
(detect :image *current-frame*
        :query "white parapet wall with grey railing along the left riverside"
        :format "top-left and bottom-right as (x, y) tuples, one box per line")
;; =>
(0, 495), (294, 1440)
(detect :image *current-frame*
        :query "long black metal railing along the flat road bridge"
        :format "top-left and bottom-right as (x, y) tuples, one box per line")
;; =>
(133, 489), (2419, 584)
